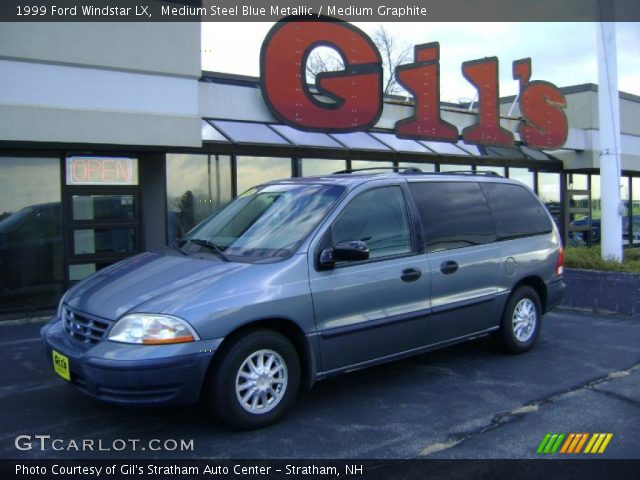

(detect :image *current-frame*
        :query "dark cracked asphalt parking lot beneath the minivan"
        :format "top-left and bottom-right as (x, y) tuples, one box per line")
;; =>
(0, 311), (640, 459)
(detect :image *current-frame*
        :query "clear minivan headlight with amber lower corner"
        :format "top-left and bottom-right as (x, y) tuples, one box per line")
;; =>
(109, 313), (200, 345)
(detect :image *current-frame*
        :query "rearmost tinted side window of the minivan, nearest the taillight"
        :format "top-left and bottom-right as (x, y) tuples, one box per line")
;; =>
(481, 183), (552, 240)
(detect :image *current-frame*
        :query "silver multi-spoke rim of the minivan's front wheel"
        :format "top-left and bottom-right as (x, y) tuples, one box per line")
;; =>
(236, 350), (288, 414)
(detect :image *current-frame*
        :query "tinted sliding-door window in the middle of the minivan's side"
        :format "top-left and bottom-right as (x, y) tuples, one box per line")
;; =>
(409, 182), (496, 252)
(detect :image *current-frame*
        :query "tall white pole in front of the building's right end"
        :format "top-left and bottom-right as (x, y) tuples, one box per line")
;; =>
(596, 19), (622, 262)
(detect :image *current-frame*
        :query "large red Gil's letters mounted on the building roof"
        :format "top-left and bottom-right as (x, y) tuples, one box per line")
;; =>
(260, 18), (568, 148)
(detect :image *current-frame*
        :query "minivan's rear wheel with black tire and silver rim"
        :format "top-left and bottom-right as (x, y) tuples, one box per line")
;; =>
(496, 286), (542, 353)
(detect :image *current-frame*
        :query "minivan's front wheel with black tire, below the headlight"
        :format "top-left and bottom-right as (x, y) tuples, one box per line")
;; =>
(206, 329), (300, 430)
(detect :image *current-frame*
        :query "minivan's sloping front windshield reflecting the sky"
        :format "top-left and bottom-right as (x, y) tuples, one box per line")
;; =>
(185, 184), (344, 262)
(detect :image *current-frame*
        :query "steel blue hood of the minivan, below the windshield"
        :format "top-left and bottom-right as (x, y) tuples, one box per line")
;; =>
(65, 248), (251, 320)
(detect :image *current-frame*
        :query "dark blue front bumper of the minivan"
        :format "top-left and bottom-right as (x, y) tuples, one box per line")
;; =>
(40, 319), (222, 405)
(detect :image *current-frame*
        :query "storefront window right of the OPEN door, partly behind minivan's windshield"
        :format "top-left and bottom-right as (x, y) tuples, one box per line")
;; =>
(167, 154), (232, 243)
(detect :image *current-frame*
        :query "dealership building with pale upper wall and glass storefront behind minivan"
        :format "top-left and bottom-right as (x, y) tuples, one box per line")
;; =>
(0, 22), (640, 318)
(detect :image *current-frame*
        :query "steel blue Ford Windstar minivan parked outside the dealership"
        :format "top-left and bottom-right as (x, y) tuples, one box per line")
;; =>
(41, 169), (564, 429)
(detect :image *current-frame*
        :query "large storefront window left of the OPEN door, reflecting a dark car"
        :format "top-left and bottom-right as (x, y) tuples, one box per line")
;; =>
(0, 157), (63, 313)
